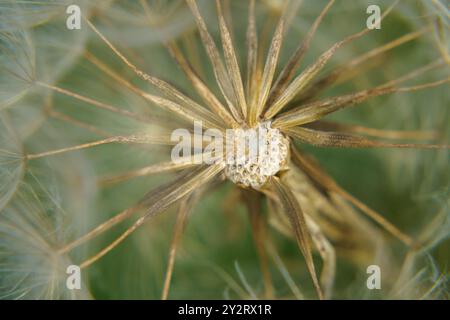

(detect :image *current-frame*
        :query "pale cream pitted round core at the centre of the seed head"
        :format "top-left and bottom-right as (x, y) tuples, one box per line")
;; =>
(225, 121), (289, 189)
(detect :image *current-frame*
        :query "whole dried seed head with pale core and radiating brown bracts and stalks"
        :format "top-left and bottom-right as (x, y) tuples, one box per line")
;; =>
(0, 0), (450, 299)
